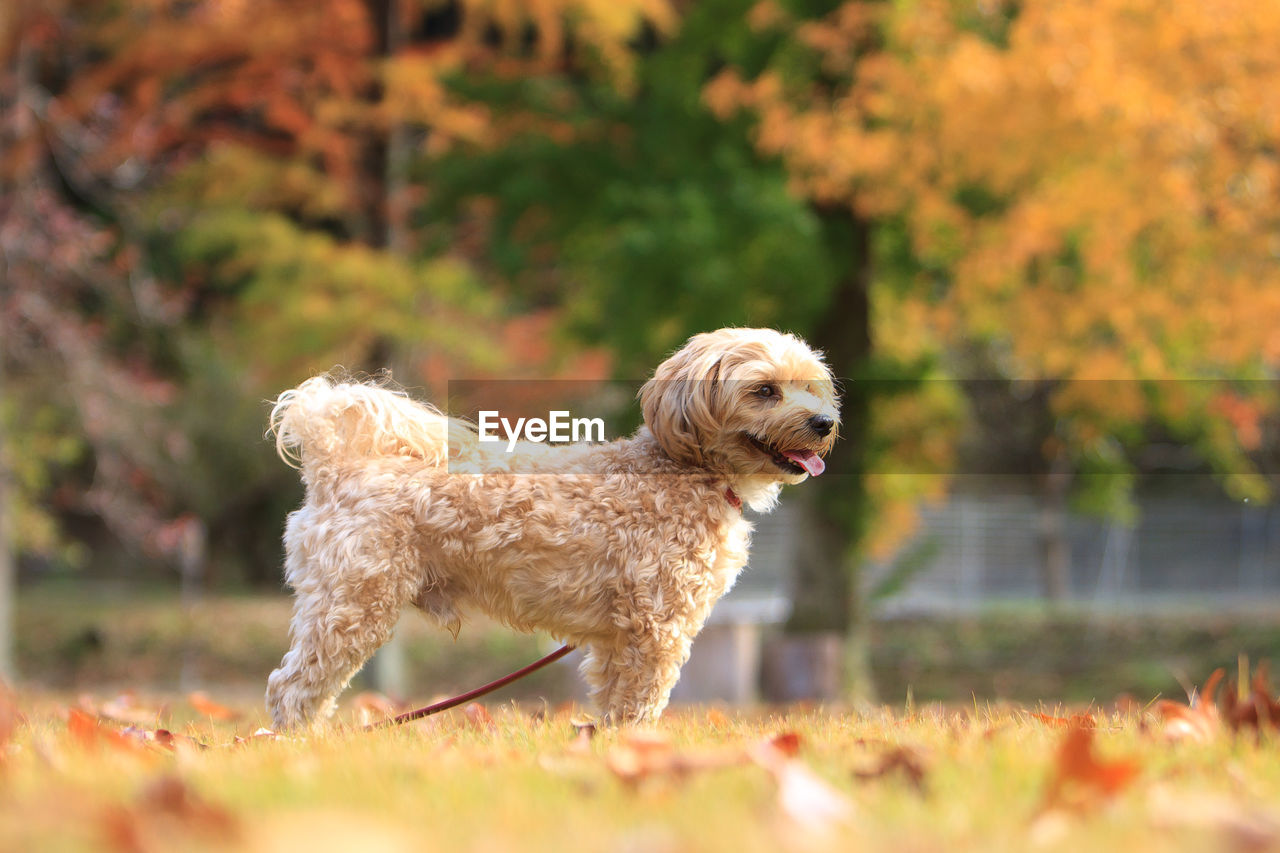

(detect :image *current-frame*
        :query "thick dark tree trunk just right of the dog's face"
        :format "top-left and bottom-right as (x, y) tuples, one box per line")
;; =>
(786, 209), (873, 698)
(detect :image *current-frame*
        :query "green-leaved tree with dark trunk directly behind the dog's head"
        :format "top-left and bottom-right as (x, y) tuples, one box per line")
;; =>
(422, 0), (956, 696)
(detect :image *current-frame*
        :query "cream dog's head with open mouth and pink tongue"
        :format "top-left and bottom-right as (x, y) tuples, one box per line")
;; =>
(640, 329), (840, 500)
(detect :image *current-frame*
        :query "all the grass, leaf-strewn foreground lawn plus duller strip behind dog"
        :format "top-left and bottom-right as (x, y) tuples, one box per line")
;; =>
(10, 588), (1280, 853)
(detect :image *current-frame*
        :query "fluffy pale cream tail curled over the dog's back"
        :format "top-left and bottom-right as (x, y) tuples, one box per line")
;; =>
(270, 377), (458, 474)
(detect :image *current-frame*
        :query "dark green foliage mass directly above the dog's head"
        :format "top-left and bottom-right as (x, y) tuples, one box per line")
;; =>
(424, 4), (837, 371)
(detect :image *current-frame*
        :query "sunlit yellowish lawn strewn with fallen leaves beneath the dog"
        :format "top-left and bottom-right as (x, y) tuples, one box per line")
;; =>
(0, 693), (1280, 853)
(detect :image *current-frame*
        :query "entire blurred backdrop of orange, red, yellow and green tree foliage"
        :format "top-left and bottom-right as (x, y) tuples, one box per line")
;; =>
(0, 0), (1280, 686)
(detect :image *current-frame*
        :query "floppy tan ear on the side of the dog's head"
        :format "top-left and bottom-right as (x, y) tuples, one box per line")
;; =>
(640, 336), (723, 465)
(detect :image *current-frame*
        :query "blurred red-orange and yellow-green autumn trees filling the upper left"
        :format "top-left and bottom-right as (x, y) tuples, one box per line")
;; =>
(0, 0), (671, 589)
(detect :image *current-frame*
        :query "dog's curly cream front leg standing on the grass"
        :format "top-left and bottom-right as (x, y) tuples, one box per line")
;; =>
(581, 629), (692, 725)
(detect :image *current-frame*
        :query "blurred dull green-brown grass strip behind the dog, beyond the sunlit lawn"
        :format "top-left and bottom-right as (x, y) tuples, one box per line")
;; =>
(17, 584), (1280, 704)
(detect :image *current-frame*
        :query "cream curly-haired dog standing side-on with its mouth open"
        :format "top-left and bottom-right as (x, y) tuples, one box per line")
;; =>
(266, 329), (838, 727)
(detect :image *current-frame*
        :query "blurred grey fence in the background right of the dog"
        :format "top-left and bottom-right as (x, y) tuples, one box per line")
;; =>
(721, 493), (1280, 613)
